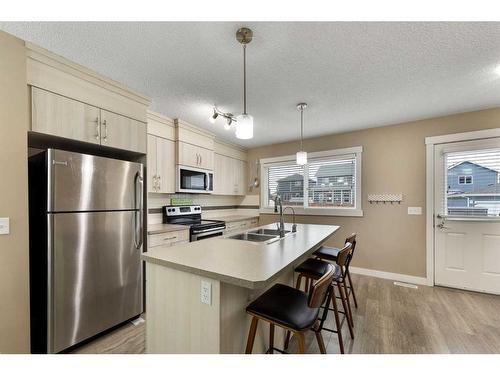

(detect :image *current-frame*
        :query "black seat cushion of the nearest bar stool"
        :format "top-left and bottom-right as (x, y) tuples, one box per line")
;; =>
(246, 284), (319, 331)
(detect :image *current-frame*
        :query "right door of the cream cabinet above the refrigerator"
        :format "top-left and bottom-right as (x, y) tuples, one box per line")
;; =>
(101, 109), (147, 154)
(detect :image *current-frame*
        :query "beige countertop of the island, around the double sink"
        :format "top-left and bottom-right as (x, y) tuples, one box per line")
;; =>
(142, 224), (339, 289)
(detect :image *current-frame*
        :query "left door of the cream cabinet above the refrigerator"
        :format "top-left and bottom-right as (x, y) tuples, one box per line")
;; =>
(31, 87), (101, 144)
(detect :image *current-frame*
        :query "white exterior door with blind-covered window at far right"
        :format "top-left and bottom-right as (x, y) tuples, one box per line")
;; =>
(434, 138), (500, 294)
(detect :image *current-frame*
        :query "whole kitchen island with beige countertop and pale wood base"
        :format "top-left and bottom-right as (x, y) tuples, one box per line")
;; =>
(142, 224), (339, 353)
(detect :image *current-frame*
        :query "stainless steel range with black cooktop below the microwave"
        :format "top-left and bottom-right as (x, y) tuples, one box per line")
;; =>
(163, 206), (226, 242)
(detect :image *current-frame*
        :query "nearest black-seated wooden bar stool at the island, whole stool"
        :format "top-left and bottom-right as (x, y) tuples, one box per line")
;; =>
(245, 264), (335, 354)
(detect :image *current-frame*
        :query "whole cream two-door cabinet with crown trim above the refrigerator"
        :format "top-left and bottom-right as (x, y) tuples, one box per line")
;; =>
(26, 42), (151, 153)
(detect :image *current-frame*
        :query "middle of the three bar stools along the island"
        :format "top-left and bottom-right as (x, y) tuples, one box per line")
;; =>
(285, 242), (354, 354)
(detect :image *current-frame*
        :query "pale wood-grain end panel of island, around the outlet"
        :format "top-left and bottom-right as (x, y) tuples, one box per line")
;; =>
(146, 262), (220, 354)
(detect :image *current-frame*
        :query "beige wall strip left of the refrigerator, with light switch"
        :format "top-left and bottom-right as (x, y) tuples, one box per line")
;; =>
(0, 32), (29, 353)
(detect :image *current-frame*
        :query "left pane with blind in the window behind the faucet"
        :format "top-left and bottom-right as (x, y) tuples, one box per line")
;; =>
(267, 163), (304, 206)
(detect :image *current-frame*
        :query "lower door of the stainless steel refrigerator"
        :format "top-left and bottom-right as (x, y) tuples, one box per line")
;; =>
(48, 211), (143, 352)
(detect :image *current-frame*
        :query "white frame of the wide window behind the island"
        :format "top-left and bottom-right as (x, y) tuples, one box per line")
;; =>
(259, 146), (363, 217)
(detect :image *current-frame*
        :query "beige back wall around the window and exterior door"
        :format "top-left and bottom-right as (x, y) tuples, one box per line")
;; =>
(248, 108), (500, 277)
